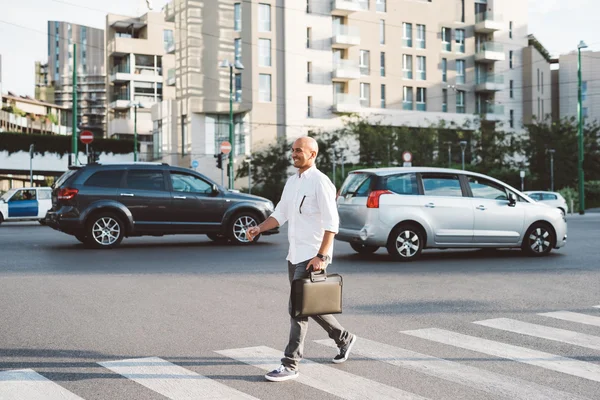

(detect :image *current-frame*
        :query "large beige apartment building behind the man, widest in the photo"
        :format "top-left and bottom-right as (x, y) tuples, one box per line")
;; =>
(153, 0), (528, 185)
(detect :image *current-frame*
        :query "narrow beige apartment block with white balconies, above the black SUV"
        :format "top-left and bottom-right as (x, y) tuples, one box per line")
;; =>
(105, 12), (175, 160)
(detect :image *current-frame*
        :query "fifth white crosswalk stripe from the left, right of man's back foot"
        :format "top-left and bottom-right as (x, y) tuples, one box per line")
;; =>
(402, 328), (600, 382)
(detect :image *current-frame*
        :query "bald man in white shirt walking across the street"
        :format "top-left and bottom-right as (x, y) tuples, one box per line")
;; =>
(247, 137), (356, 382)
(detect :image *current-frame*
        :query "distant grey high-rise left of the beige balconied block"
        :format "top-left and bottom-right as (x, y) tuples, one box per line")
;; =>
(47, 21), (106, 137)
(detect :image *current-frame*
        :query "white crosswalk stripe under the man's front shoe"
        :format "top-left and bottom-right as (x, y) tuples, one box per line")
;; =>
(217, 346), (432, 400)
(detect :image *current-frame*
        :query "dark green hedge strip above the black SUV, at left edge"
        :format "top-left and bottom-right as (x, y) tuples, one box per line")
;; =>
(0, 132), (139, 156)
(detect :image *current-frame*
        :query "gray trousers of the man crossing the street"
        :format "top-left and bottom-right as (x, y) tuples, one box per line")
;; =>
(281, 260), (352, 370)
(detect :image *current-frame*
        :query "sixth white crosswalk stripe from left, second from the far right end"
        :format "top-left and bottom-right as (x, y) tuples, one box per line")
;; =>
(474, 318), (600, 350)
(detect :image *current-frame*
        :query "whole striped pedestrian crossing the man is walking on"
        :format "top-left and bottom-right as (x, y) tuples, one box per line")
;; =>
(0, 306), (600, 400)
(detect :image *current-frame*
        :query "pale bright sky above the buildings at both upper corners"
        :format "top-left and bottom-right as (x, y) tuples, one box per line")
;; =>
(0, 0), (600, 96)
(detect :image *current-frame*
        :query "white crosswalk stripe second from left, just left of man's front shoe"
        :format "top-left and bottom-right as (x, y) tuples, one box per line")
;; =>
(98, 357), (256, 400)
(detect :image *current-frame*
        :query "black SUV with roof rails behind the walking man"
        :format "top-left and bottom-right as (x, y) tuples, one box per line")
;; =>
(46, 162), (278, 248)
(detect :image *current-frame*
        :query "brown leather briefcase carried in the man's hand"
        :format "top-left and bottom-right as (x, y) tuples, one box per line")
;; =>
(291, 271), (343, 318)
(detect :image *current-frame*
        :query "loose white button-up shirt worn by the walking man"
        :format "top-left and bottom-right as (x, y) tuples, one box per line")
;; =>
(271, 165), (340, 264)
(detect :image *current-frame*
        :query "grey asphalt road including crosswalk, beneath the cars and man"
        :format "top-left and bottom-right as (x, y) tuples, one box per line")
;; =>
(0, 214), (600, 400)
